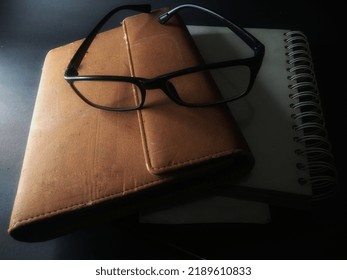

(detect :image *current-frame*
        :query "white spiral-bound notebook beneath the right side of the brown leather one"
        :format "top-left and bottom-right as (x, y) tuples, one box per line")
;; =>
(222, 28), (338, 205)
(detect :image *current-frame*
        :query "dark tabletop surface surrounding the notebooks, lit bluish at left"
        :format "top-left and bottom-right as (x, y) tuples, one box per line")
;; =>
(0, 0), (347, 259)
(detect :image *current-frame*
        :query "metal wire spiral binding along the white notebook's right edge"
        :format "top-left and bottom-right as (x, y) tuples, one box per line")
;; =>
(284, 31), (338, 200)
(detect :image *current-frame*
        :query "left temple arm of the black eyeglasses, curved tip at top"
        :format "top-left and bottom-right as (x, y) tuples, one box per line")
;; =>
(65, 5), (151, 76)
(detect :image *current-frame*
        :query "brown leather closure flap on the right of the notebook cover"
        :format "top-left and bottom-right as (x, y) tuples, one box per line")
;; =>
(123, 11), (249, 175)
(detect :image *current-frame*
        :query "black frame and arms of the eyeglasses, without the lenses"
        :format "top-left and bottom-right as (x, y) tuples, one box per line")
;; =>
(64, 4), (265, 111)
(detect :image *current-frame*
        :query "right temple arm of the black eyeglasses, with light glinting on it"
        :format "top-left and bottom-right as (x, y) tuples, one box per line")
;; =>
(158, 4), (265, 54)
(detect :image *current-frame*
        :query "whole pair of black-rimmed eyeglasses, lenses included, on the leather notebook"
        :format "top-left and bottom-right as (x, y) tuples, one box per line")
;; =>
(64, 4), (265, 111)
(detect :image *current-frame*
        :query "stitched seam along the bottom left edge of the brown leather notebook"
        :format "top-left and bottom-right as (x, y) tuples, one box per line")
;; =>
(10, 178), (169, 229)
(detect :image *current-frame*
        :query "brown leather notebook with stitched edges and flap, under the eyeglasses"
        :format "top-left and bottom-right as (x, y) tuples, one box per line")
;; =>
(9, 8), (253, 241)
